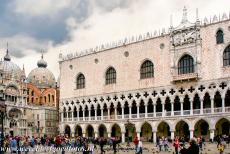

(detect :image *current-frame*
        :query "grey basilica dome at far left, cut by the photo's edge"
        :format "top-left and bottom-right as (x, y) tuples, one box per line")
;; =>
(0, 49), (24, 81)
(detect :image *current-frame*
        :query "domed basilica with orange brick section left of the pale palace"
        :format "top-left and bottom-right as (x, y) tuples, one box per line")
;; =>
(0, 49), (59, 136)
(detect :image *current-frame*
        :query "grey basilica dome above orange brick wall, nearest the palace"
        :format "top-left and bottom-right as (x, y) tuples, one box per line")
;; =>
(27, 55), (56, 88)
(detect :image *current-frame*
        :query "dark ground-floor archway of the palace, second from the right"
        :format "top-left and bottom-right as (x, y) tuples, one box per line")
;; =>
(194, 119), (210, 138)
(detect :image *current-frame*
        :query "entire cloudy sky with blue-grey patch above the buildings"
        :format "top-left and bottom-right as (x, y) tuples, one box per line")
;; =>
(0, 0), (230, 77)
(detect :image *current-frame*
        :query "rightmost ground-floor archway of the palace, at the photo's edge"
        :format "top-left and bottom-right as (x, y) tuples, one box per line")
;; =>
(215, 118), (230, 135)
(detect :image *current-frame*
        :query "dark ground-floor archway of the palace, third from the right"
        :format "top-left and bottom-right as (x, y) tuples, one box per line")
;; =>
(175, 121), (190, 141)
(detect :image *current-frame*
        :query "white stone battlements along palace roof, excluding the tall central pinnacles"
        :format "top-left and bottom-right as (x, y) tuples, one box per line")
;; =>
(59, 12), (230, 62)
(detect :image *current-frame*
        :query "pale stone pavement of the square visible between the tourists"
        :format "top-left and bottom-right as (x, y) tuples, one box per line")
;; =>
(3, 143), (230, 154)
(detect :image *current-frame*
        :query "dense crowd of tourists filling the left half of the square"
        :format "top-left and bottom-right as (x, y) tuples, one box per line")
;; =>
(1, 135), (121, 154)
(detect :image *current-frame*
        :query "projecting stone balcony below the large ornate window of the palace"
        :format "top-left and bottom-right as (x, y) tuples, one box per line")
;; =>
(172, 65), (199, 83)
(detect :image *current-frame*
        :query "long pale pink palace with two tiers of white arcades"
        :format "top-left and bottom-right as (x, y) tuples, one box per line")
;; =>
(59, 8), (230, 142)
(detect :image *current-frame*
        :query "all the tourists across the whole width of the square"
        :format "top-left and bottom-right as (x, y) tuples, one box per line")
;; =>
(1, 135), (230, 154)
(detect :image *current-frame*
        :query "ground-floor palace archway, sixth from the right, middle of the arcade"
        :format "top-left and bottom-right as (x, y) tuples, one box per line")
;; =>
(125, 122), (137, 141)
